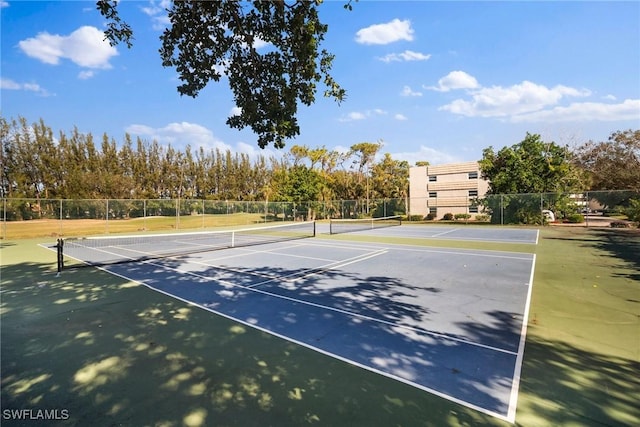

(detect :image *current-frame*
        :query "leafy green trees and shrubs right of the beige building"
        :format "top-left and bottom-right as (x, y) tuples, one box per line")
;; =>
(479, 130), (640, 224)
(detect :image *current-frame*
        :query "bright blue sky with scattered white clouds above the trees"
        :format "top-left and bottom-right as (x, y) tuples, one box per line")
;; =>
(0, 0), (640, 164)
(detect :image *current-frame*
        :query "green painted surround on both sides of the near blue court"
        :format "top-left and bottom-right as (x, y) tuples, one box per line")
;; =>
(0, 227), (640, 427)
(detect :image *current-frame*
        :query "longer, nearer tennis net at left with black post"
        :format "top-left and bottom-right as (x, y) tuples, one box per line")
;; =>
(56, 221), (316, 271)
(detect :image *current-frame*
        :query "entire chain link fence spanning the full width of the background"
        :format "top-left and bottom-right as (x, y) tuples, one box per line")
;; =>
(1, 190), (640, 239)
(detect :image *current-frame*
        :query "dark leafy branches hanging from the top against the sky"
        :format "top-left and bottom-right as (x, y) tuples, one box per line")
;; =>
(97, 0), (344, 148)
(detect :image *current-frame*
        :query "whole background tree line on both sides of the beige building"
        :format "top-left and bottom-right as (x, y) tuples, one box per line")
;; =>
(0, 117), (640, 208)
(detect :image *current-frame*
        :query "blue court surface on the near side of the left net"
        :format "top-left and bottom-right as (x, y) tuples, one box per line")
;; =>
(80, 236), (535, 422)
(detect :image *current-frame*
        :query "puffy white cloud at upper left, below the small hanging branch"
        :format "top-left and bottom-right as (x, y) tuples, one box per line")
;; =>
(18, 26), (118, 69)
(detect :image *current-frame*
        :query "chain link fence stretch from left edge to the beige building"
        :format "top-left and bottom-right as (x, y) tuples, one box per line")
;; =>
(0, 198), (408, 239)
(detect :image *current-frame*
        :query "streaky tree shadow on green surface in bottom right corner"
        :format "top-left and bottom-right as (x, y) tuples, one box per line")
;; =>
(517, 335), (640, 426)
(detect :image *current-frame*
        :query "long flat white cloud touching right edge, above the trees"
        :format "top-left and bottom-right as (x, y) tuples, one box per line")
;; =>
(511, 99), (640, 123)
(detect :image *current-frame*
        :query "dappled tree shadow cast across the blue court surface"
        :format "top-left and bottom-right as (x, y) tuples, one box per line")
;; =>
(108, 252), (526, 417)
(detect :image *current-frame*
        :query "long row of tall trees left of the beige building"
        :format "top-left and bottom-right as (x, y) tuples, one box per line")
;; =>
(0, 117), (409, 206)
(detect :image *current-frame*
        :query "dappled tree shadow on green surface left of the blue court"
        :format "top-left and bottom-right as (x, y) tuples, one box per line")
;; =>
(1, 262), (504, 426)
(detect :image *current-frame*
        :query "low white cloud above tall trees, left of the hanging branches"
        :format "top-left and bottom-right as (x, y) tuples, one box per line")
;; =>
(125, 122), (231, 151)
